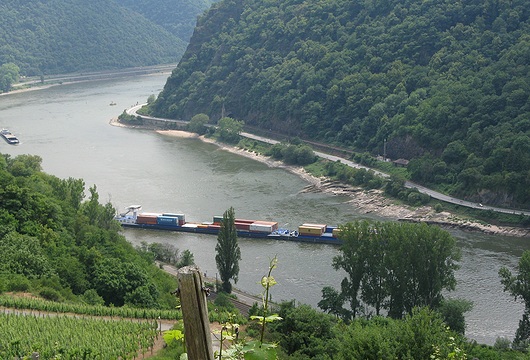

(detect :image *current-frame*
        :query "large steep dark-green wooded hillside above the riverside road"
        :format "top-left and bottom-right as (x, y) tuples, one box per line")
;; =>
(150, 0), (530, 208)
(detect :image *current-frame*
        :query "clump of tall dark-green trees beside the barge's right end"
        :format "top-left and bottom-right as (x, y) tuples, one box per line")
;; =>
(330, 221), (460, 318)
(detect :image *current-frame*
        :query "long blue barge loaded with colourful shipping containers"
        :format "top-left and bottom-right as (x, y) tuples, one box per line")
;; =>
(115, 205), (342, 245)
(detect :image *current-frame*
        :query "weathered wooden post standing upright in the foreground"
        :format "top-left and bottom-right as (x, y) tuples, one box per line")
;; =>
(177, 265), (214, 360)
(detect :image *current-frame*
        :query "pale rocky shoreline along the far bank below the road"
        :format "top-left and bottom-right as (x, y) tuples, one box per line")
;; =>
(110, 119), (530, 237)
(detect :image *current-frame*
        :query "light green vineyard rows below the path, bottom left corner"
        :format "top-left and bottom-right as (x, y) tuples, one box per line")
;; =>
(0, 313), (156, 359)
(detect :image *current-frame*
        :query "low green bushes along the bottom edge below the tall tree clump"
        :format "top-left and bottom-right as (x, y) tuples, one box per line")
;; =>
(268, 301), (468, 360)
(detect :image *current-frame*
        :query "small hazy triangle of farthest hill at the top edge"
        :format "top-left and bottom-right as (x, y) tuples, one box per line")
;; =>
(116, 0), (217, 43)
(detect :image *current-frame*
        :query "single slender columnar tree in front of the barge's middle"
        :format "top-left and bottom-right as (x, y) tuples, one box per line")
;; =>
(215, 207), (241, 293)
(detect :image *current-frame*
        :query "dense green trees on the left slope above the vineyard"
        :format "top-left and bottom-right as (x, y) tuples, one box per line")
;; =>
(0, 155), (176, 309)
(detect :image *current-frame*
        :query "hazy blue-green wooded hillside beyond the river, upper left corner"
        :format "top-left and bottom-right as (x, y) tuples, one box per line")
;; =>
(0, 0), (186, 75)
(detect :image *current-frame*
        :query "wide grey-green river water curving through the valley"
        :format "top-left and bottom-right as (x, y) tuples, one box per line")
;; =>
(0, 74), (528, 344)
